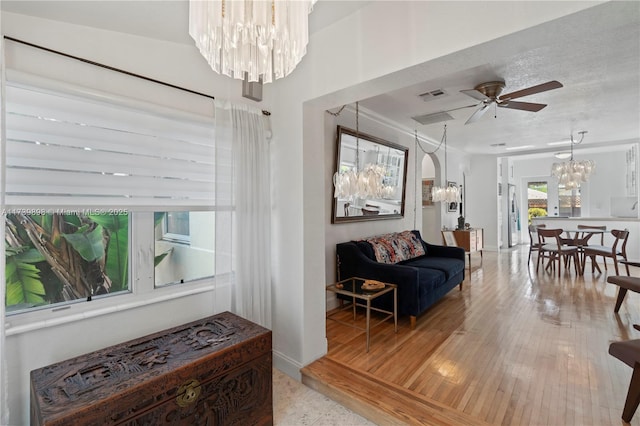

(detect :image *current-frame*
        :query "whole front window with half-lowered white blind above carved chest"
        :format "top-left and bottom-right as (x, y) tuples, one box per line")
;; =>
(5, 73), (220, 314)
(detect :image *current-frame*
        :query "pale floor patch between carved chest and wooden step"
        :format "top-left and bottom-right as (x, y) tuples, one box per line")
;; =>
(273, 368), (374, 426)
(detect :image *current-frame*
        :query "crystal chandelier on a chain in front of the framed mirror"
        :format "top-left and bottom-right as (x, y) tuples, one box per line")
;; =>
(333, 102), (394, 201)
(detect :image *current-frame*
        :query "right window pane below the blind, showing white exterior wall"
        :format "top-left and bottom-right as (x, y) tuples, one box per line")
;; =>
(154, 211), (215, 287)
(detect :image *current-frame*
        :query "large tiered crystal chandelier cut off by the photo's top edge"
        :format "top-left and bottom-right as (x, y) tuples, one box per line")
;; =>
(189, 0), (317, 83)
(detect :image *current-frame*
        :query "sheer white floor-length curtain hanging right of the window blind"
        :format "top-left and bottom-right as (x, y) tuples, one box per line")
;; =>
(215, 101), (271, 328)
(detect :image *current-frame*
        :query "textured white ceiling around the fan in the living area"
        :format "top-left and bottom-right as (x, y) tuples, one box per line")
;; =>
(360, 2), (640, 155)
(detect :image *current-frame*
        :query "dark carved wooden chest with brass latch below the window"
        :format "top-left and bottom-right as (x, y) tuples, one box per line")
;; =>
(31, 312), (273, 426)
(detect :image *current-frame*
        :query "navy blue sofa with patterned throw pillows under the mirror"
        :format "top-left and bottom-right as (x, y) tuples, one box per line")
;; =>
(336, 230), (465, 329)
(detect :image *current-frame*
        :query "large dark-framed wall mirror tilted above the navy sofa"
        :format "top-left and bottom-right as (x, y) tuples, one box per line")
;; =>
(331, 126), (409, 223)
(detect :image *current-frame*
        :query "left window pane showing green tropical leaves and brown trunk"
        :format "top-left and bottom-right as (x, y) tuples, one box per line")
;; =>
(5, 209), (129, 313)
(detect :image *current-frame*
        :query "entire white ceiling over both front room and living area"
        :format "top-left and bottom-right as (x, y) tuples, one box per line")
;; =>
(1, 0), (640, 155)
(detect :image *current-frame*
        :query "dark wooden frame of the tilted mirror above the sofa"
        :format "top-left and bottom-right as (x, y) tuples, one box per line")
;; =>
(331, 126), (409, 224)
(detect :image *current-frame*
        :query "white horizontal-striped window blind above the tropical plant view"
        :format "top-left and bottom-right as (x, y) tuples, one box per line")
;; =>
(5, 78), (216, 211)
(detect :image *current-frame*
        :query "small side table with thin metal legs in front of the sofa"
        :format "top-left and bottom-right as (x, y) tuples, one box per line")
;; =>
(327, 277), (398, 352)
